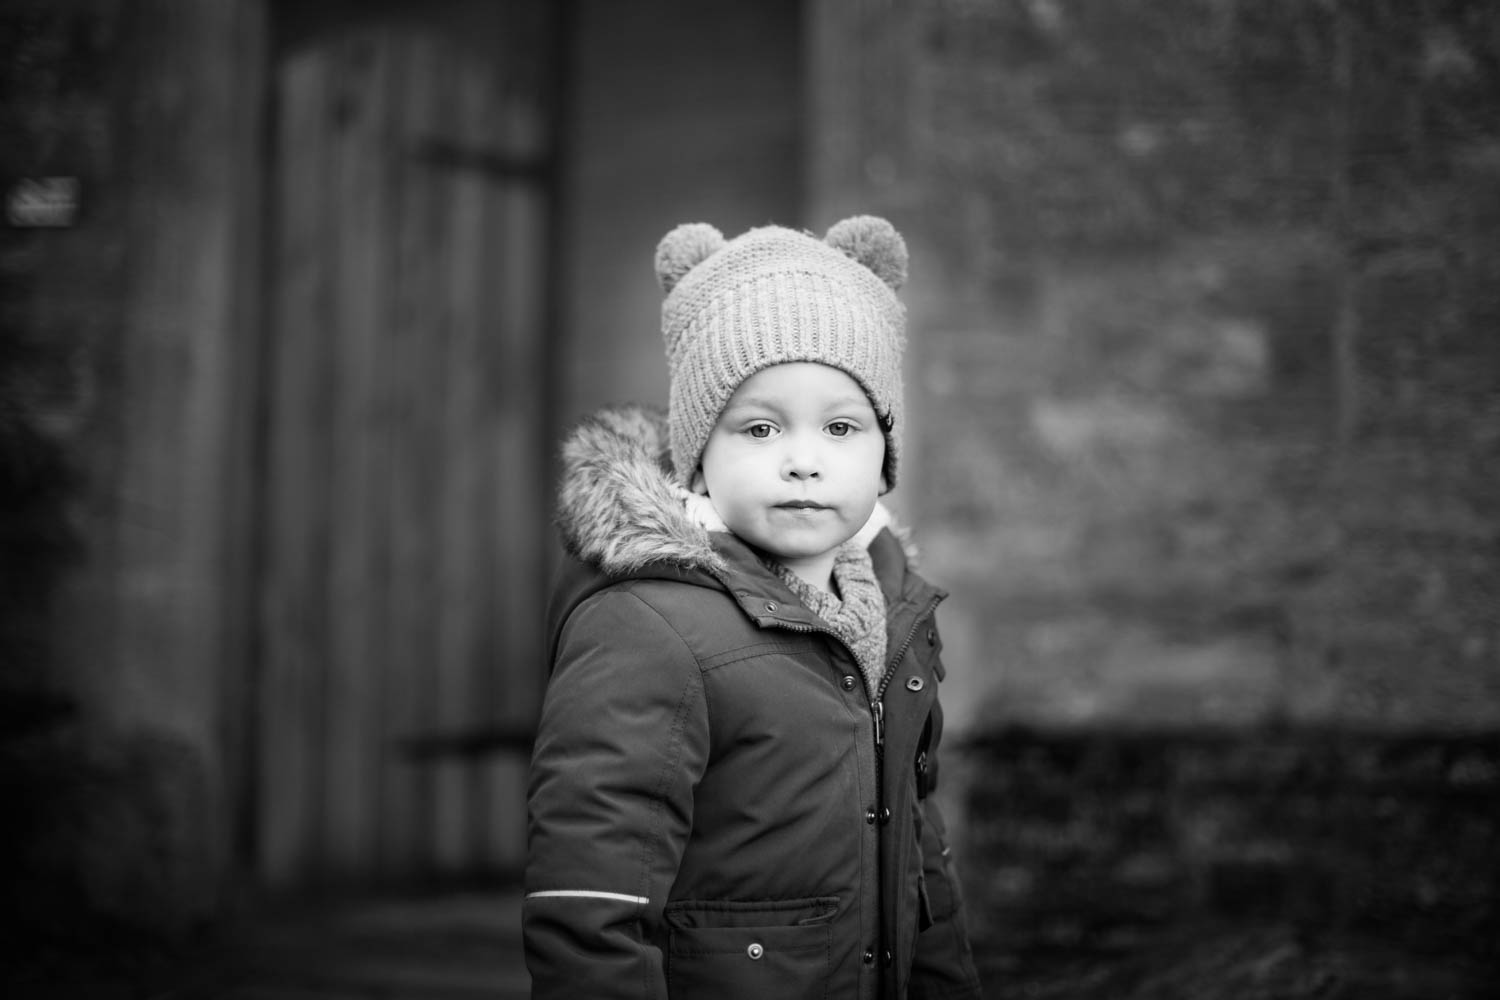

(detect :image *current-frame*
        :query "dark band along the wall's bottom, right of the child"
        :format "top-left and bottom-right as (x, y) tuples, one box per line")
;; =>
(966, 730), (1500, 1000)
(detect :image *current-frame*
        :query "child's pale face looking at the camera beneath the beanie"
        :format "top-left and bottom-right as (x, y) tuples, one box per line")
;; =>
(693, 361), (885, 589)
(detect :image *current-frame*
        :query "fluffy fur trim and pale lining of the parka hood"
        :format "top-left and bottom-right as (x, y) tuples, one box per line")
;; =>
(557, 406), (915, 576)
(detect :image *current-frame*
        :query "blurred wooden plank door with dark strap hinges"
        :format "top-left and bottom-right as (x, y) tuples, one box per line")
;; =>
(251, 0), (551, 886)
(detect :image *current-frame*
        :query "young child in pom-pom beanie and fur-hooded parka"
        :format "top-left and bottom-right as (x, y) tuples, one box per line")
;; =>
(524, 216), (980, 1000)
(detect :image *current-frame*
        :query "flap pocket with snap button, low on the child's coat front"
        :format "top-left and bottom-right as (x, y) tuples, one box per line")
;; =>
(665, 897), (839, 1000)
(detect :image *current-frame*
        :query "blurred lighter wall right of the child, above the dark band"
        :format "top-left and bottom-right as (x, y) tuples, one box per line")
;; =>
(813, 0), (1500, 729)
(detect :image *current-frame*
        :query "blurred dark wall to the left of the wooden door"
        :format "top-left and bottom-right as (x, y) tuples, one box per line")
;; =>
(0, 0), (255, 951)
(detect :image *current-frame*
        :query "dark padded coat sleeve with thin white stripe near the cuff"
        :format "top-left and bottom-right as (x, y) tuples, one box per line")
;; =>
(522, 589), (708, 1000)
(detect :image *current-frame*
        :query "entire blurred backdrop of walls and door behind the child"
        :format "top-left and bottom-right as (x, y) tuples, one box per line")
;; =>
(0, 0), (1500, 997)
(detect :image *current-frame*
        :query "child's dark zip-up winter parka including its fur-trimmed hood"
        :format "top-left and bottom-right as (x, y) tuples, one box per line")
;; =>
(524, 409), (980, 1000)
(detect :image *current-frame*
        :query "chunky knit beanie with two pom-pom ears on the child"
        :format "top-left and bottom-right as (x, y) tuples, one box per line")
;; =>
(656, 216), (906, 487)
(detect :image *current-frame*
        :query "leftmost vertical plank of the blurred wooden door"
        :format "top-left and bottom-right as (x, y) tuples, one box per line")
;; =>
(257, 55), (330, 886)
